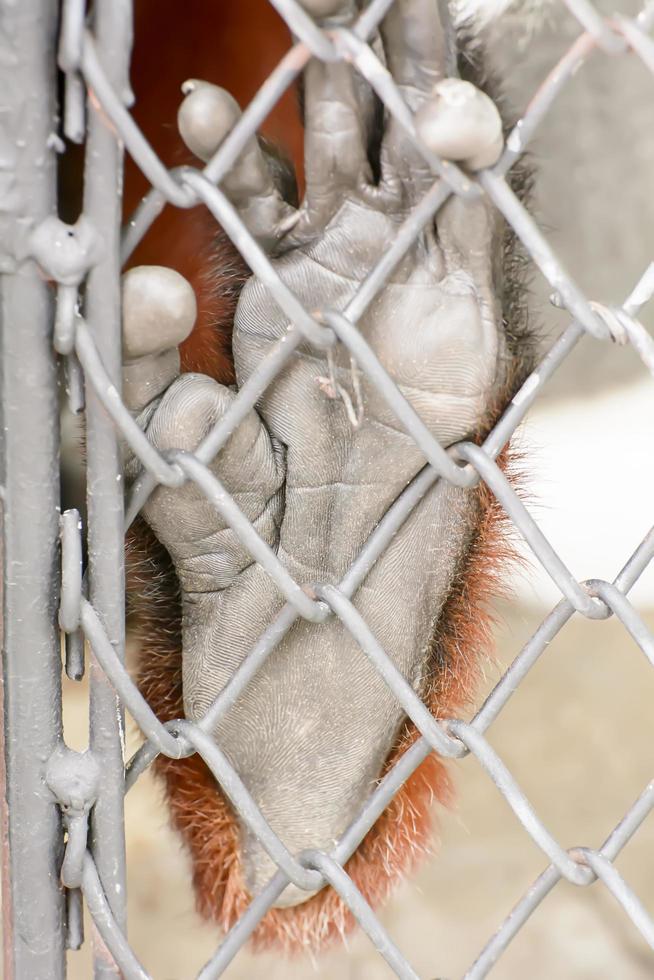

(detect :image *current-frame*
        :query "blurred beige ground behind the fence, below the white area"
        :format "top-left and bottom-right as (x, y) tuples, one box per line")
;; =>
(60, 605), (654, 980)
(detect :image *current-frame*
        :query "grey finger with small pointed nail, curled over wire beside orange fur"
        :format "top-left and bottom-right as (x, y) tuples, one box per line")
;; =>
(177, 79), (296, 246)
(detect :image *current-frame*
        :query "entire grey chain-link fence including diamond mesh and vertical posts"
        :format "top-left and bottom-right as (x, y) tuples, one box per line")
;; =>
(0, 0), (654, 980)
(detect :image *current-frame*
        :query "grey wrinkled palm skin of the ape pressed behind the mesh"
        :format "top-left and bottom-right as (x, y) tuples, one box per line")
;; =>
(126, 0), (505, 905)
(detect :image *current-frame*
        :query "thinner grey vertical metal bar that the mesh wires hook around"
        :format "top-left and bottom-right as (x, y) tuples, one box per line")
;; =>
(84, 0), (132, 980)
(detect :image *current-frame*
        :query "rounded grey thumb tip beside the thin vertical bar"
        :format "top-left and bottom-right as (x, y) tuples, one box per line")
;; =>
(122, 265), (197, 413)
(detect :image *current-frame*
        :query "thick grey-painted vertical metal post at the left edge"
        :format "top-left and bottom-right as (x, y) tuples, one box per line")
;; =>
(0, 0), (65, 980)
